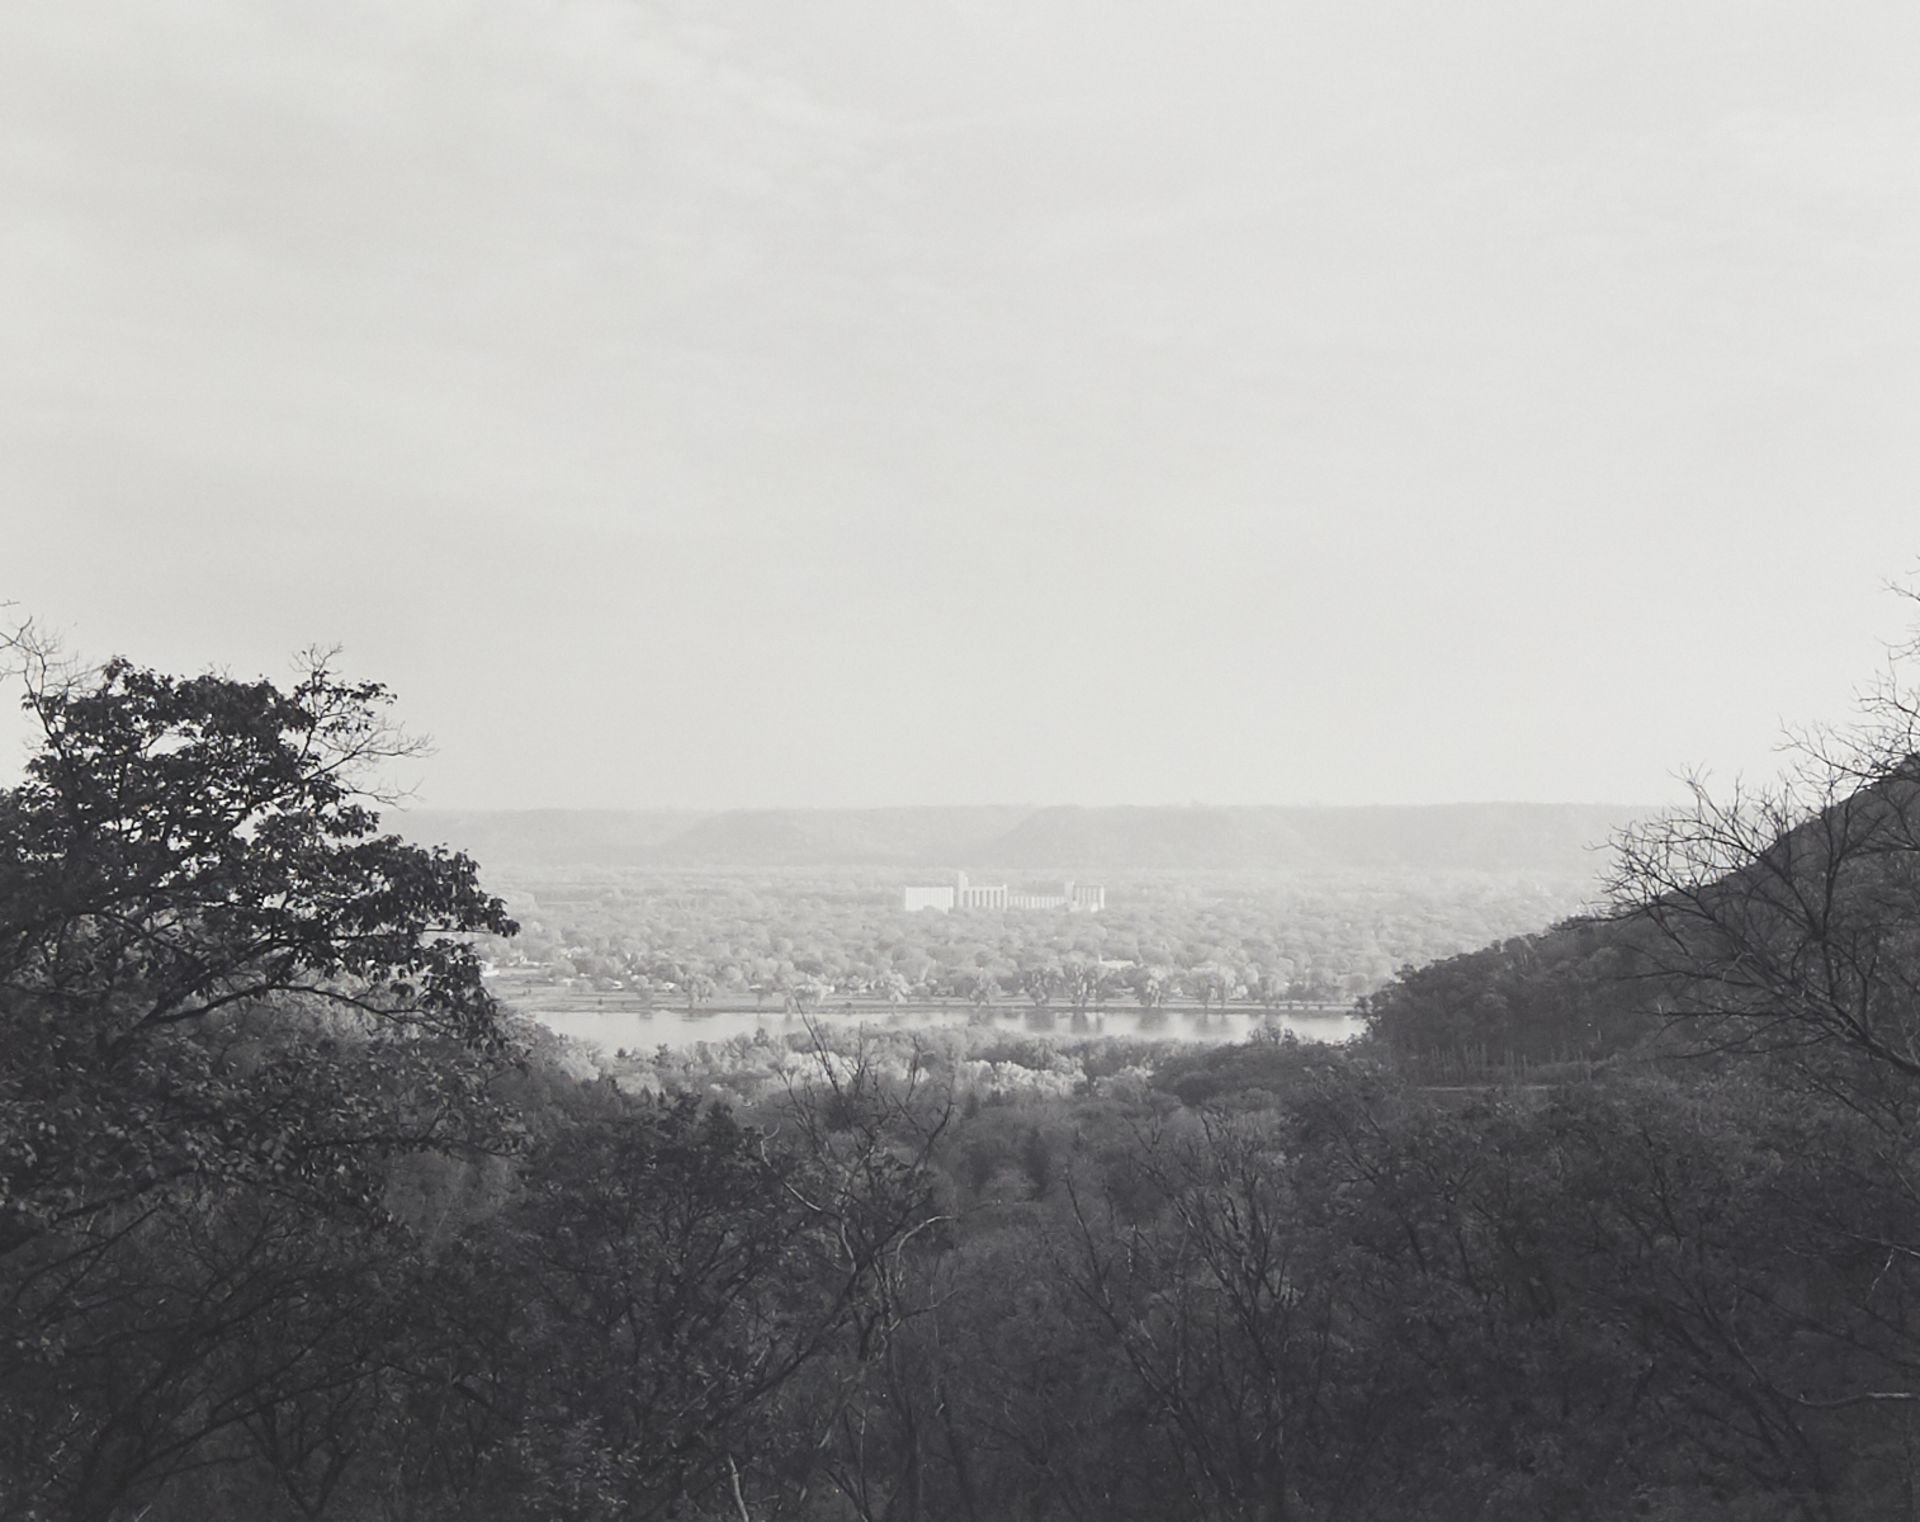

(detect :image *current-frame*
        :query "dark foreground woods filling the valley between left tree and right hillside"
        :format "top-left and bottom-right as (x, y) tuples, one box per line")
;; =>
(18, 1005), (1920, 1522)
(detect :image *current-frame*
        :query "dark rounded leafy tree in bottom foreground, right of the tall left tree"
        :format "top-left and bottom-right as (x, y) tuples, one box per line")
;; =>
(453, 1096), (910, 1518)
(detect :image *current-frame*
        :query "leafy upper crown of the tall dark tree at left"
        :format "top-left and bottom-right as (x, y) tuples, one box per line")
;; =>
(0, 637), (515, 1061)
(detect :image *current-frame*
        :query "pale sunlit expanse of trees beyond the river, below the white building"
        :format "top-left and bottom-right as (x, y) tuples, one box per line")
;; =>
(488, 871), (1596, 1010)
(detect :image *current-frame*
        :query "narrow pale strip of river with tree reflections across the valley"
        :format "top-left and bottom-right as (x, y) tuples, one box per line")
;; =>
(528, 1010), (1361, 1052)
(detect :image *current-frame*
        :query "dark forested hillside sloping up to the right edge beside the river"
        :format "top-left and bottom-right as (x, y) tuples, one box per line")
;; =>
(1363, 737), (1920, 1082)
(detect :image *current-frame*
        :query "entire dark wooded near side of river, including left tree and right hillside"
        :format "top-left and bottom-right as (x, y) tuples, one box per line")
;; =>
(11, 641), (1920, 1522)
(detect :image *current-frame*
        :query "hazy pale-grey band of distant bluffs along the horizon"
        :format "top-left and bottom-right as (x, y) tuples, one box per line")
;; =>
(388, 802), (1657, 875)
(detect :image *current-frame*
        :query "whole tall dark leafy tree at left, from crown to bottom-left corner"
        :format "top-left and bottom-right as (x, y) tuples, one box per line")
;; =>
(0, 631), (513, 1518)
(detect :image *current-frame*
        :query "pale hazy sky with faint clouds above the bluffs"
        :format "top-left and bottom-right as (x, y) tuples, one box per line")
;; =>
(0, 0), (1920, 806)
